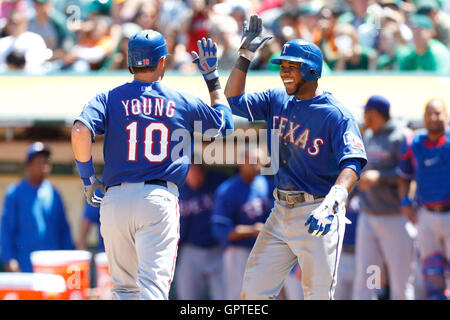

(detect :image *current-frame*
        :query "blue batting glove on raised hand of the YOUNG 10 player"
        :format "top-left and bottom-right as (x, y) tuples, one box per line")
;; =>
(191, 38), (219, 81)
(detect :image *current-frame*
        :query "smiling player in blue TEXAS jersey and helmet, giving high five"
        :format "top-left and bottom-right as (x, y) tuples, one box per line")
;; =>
(225, 15), (367, 299)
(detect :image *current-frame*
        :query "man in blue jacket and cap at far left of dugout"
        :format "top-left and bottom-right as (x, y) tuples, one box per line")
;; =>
(1, 142), (74, 272)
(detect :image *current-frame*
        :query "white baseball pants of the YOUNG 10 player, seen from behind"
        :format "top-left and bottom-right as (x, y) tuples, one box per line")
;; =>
(100, 182), (179, 300)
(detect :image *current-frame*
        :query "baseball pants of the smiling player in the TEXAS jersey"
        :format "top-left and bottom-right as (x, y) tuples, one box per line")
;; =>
(241, 200), (345, 300)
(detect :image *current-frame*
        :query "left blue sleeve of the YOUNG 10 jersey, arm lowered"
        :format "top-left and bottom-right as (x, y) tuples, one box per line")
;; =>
(75, 92), (108, 141)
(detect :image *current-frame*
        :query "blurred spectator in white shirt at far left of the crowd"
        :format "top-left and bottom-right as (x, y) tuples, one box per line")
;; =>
(0, 10), (52, 73)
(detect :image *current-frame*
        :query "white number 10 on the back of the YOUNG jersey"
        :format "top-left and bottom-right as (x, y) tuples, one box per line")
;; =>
(125, 121), (169, 162)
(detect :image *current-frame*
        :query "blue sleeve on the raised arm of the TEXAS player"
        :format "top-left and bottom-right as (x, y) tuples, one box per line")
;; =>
(228, 90), (271, 121)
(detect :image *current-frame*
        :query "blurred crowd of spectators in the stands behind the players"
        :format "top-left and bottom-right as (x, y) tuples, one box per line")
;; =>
(0, 0), (450, 74)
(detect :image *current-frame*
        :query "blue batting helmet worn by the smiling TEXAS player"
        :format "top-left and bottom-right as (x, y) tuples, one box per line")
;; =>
(270, 39), (323, 81)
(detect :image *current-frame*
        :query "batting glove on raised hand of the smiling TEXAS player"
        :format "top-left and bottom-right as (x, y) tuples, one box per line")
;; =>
(239, 14), (272, 61)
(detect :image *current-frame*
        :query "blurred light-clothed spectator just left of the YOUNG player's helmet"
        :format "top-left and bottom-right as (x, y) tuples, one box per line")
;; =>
(62, 15), (121, 72)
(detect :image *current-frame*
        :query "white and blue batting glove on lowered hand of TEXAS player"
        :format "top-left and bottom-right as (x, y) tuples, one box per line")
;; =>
(305, 185), (351, 237)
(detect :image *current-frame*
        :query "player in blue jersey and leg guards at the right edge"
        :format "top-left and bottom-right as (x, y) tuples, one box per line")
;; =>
(398, 99), (450, 299)
